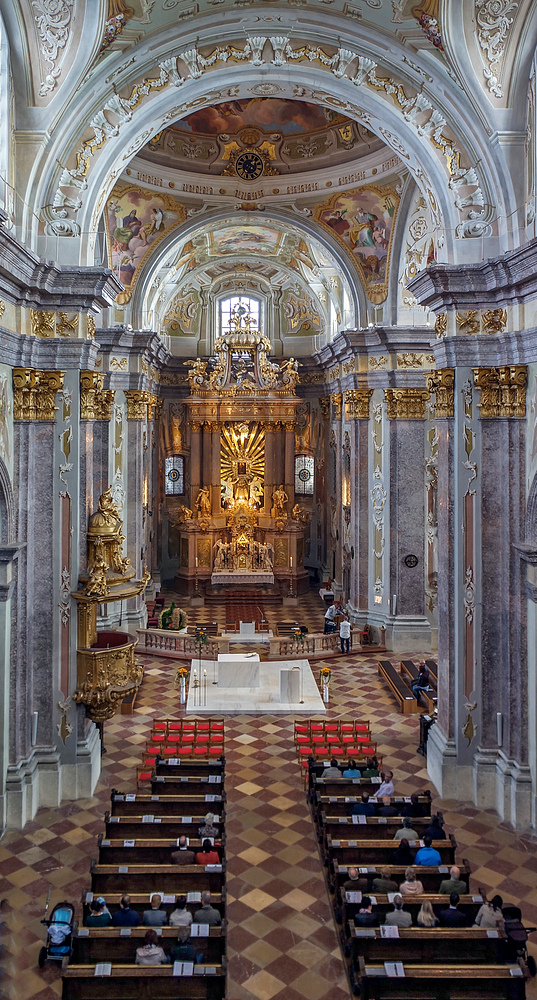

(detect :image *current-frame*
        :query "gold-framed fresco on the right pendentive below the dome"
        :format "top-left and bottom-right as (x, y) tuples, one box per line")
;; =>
(314, 184), (399, 303)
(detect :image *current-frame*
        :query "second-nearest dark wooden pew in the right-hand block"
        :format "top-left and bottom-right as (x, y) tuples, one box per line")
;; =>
(349, 920), (506, 964)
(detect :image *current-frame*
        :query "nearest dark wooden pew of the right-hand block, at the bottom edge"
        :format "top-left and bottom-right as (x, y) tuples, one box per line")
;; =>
(352, 958), (525, 1000)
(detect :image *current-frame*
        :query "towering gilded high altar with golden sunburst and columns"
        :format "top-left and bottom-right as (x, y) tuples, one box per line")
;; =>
(172, 306), (309, 596)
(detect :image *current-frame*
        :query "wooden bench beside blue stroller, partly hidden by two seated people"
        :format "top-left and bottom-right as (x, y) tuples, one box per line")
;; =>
(72, 926), (226, 965)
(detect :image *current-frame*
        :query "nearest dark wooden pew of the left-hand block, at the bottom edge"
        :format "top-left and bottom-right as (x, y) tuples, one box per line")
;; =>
(63, 960), (226, 1000)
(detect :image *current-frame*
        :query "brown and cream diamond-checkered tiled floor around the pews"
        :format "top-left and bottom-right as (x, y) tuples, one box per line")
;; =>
(0, 596), (537, 1000)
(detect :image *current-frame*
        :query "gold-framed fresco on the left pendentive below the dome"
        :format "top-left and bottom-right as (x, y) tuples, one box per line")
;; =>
(105, 185), (186, 305)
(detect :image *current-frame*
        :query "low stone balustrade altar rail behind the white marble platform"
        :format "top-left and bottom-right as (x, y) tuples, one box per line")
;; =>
(136, 628), (385, 660)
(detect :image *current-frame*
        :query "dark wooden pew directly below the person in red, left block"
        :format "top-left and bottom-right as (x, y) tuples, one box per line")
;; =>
(90, 864), (226, 896)
